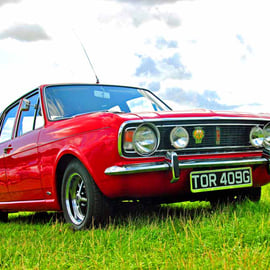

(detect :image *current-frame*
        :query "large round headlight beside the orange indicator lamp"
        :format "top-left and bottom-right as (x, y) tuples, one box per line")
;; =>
(133, 124), (159, 156)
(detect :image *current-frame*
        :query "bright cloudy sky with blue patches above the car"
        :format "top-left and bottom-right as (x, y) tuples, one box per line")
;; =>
(0, 0), (270, 112)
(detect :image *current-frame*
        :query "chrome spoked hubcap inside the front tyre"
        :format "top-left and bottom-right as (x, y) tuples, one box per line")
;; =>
(65, 173), (88, 225)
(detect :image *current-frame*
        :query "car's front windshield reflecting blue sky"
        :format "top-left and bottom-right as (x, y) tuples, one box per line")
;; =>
(45, 85), (170, 120)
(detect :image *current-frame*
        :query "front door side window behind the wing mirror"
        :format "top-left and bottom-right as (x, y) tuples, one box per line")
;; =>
(17, 94), (43, 136)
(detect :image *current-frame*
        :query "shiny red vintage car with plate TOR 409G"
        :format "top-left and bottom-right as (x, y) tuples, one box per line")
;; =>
(0, 84), (270, 229)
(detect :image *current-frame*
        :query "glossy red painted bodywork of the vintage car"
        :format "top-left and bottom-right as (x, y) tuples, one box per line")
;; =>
(0, 83), (270, 211)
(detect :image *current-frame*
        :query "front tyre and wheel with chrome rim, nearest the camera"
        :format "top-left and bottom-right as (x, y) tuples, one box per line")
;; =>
(61, 160), (111, 230)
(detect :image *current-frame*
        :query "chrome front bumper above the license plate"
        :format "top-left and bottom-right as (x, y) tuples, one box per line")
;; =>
(105, 157), (270, 183)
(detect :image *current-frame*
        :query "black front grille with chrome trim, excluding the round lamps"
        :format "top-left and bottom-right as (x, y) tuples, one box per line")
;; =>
(122, 118), (269, 157)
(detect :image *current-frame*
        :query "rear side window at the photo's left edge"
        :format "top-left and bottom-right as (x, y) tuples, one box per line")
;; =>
(0, 104), (19, 143)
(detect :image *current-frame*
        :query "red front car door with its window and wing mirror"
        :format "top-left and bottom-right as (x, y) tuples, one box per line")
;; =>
(4, 92), (44, 201)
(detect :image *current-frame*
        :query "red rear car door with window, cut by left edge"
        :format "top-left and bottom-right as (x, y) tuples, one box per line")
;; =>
(0, 102), (19, 202)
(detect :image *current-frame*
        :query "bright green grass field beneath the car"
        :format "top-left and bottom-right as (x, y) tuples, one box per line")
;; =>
(0, 186), (270, 269)
